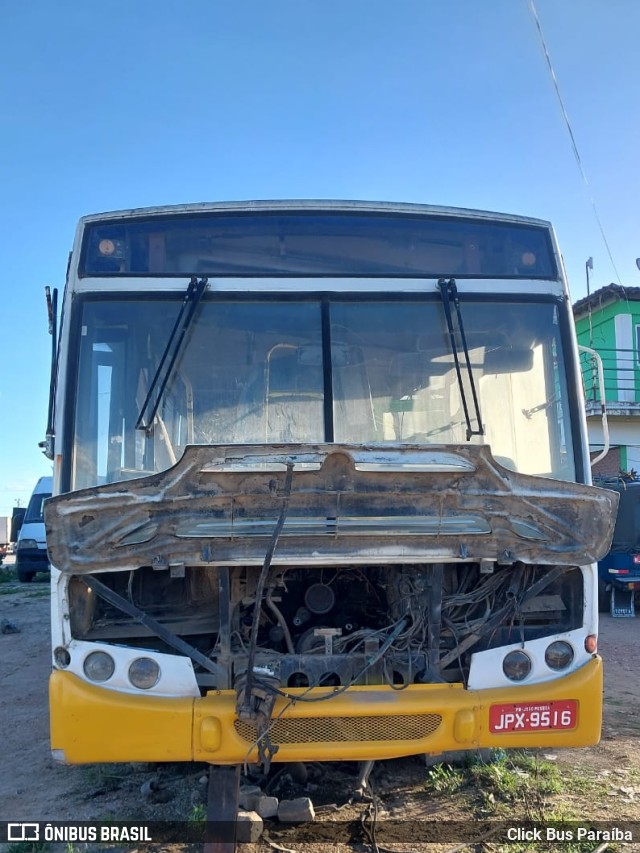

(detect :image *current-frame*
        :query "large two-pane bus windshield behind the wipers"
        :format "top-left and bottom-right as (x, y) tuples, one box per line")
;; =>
(72, 295), (575, 489)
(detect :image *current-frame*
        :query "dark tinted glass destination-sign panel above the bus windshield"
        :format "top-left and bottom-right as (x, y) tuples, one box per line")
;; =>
(80, 211), (558, 280)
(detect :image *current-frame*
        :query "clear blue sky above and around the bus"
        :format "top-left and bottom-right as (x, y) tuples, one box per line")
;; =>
(0, 0), (640, 515)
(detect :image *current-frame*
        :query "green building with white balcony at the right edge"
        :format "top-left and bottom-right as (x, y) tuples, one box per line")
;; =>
(573, 284), (640, 476)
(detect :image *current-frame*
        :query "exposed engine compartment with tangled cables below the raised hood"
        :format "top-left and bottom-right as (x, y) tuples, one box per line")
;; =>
(69, 562), (583, 692)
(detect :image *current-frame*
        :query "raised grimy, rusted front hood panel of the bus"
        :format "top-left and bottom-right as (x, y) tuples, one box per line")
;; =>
(45, 444), (618, 573)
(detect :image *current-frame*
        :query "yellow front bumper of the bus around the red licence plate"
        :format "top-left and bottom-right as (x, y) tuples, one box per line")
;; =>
(49, 656), (602, 764)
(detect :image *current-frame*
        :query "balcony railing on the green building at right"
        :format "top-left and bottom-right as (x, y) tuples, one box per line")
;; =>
(580, 347), (640, 415)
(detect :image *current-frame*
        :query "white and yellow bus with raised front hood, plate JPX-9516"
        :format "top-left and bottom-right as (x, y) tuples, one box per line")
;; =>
(45, 201), (617, 770)
